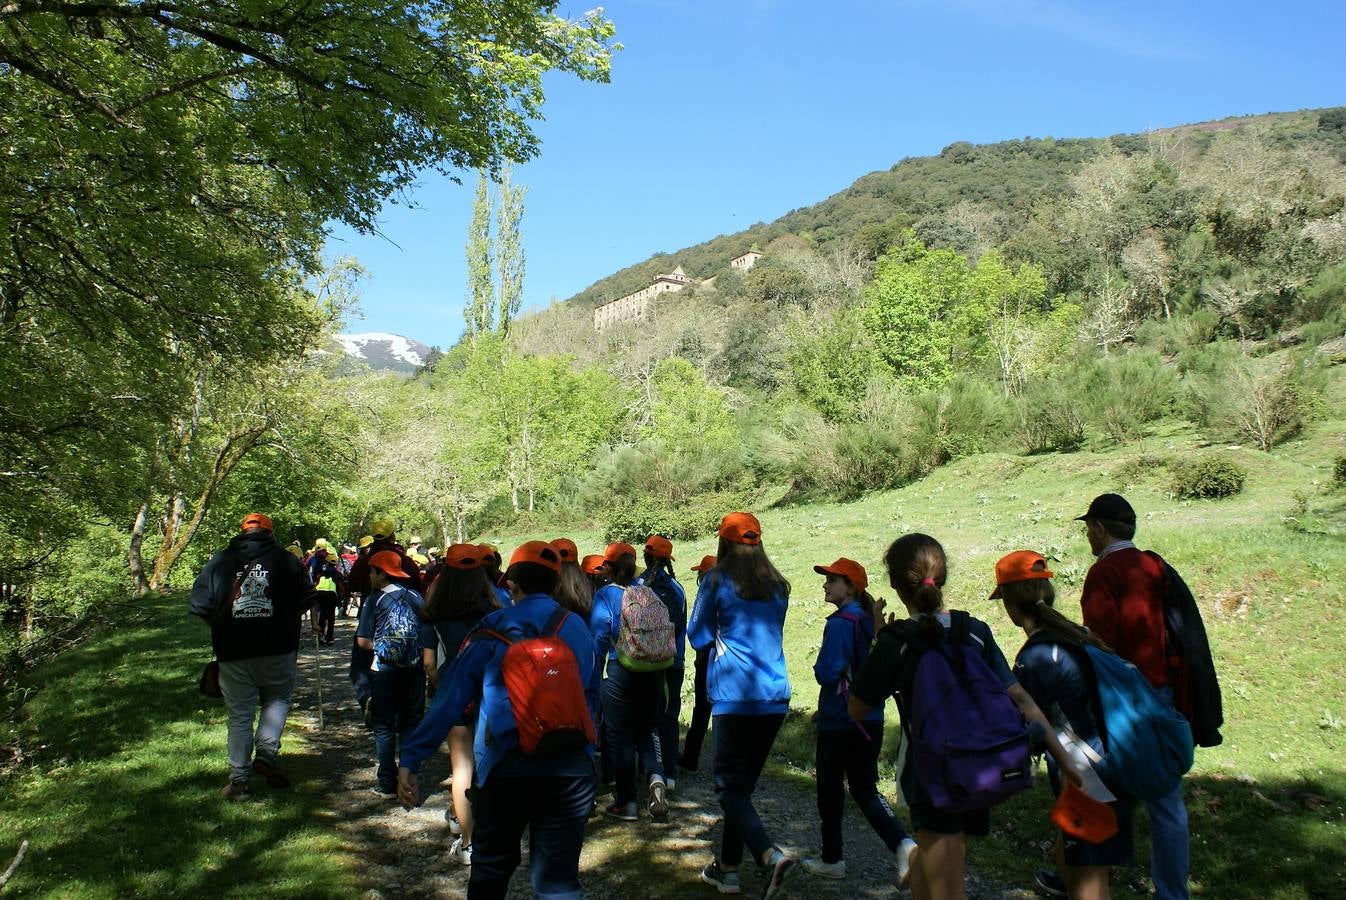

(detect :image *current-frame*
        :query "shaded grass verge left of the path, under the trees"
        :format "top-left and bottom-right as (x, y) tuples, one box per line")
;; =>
(0, 596), (359, 897)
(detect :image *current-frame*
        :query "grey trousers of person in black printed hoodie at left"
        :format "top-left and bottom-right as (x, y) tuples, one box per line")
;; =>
(219, 654), (299, 782)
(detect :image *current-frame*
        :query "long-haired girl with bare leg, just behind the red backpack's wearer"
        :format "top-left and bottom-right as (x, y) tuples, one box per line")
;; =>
(420, 543), (501, 865)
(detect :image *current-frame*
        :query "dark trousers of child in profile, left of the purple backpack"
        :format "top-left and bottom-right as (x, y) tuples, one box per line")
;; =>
(814, 721), (907, 862)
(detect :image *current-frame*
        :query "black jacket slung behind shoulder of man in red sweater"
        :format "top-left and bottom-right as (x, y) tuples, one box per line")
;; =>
(1145, 550), (1225, 747)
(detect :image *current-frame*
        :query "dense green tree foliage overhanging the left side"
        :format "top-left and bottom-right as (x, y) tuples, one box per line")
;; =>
(0, 0), (612, 669)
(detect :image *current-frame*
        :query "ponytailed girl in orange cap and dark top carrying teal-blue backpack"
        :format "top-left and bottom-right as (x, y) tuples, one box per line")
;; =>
(991, 550), (1136, 900)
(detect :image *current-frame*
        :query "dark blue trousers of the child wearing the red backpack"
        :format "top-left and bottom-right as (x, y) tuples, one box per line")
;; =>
(467, 775), (594, 900)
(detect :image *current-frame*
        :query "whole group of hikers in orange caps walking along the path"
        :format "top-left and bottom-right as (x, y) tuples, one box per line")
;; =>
(191, 494), (1221, 900)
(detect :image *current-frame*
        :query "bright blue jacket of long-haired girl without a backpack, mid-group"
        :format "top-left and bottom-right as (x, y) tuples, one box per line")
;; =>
(686, 570), (790, 716)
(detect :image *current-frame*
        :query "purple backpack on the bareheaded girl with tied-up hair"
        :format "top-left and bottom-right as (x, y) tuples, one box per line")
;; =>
(898, 611), (1032, 813)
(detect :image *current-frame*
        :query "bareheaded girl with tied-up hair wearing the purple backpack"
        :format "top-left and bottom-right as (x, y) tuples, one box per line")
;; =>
(849, 534), (1079, 900)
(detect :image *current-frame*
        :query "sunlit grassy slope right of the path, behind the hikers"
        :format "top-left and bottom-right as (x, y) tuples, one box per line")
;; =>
(499, 378), (1346, 899)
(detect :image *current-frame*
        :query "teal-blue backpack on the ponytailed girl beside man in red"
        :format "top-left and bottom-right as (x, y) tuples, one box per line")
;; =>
(1085, 644), (1193, 800)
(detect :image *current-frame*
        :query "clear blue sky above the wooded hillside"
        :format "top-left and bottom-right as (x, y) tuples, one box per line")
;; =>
(328, 0), (1346, 346)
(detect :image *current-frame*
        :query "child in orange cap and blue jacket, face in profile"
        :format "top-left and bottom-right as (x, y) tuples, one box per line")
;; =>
(804, 558), (917, 885)
